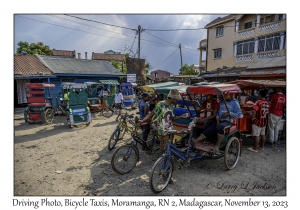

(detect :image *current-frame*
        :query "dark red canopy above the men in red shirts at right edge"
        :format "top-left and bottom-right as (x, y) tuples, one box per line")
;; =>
(226, 80), (286, 90)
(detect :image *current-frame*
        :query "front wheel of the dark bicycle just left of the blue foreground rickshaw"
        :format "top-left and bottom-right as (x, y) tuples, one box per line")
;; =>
(111, 144), (139, 175)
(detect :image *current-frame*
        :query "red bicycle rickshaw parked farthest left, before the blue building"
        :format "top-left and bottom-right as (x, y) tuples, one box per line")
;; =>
(24, 83), (55, 124)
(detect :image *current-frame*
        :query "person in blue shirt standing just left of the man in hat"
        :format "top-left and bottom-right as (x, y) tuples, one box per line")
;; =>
(139, 92), (150, 151)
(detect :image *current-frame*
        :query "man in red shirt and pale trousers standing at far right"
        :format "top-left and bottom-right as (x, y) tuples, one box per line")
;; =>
(268, 88), (286, 146)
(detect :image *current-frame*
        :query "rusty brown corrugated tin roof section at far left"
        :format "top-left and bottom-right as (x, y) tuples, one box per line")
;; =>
(14, 54), (53, 77)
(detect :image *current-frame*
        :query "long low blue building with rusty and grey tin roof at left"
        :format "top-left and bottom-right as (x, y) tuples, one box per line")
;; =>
(14, 54), (126, 105)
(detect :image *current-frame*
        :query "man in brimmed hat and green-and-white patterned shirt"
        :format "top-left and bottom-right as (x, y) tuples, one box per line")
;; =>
(139, 89), (187, 150)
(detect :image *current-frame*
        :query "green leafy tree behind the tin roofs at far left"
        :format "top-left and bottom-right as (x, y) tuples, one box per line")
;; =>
(17, 41), (53, 55)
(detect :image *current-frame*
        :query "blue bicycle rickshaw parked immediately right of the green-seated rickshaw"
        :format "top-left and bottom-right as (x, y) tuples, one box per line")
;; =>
(85, 82), (113, 118)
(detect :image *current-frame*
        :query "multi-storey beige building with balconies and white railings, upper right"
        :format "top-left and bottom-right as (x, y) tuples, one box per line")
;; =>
(199, 14), (286, 72)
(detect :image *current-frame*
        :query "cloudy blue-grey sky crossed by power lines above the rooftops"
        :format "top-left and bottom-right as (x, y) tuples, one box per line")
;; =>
(14, 13), (226, 74)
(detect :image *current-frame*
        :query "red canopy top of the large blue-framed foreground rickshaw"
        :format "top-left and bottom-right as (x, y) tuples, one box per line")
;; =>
(186, 84), (242, 95)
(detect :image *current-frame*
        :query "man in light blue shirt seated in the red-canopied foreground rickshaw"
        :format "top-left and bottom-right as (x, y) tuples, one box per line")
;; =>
(196, 92), (243, 154)
